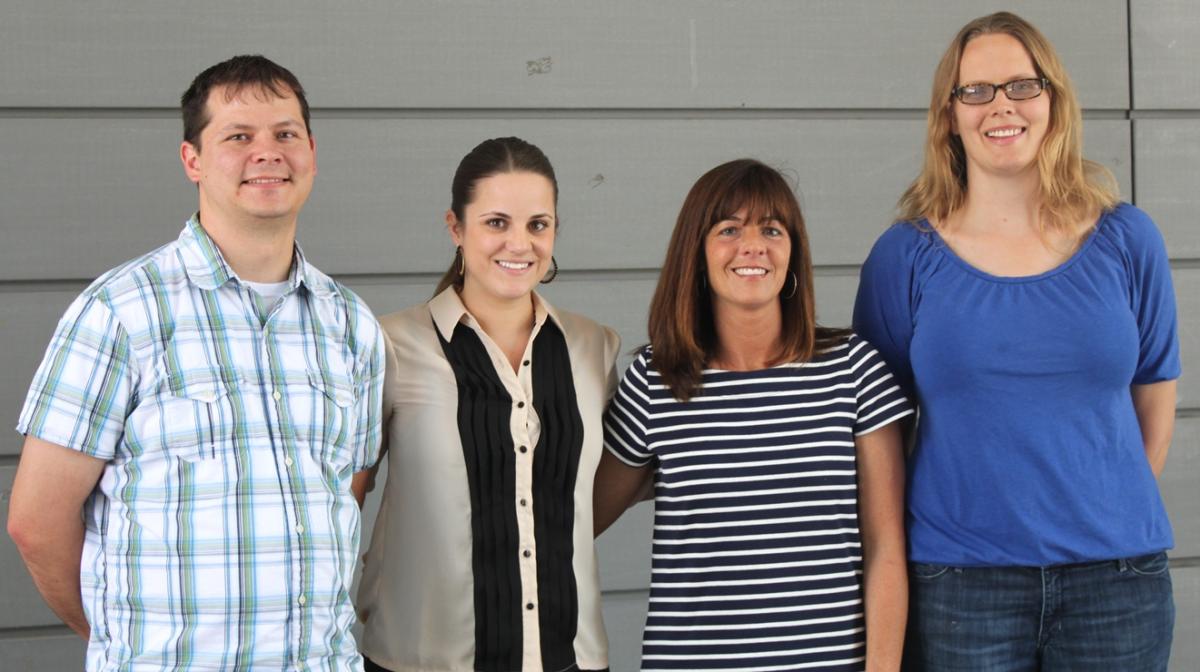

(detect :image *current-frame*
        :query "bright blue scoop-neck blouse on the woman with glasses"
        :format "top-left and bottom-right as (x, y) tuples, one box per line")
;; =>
(854, 203), (1180, 566)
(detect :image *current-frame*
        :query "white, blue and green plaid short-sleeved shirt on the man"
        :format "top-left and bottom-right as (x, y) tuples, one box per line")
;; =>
(17, 217), (384, 671)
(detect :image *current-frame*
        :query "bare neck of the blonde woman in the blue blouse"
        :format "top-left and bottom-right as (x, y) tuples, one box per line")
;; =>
(949, 167), (1042, 234)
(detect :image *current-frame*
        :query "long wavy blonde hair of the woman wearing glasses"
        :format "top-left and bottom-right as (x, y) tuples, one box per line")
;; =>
(898, 12), (1117, 233)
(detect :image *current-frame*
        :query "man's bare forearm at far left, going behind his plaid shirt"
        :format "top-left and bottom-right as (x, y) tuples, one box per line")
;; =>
(17, 518), (90, 640)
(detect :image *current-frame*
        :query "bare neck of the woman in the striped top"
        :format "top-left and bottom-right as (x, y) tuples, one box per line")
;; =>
(709, 302), (784, 371)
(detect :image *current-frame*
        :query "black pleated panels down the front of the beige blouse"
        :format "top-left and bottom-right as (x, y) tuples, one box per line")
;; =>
(438, 320), (583, 672)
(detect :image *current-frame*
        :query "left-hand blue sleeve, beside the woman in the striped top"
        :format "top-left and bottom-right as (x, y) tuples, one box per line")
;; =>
(853, 223), (918, 394)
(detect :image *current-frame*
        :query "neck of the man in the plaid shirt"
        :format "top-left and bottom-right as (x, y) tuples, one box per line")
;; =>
(200, 210), (296, 282)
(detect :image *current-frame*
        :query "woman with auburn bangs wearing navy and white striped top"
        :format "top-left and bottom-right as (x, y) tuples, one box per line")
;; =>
(593, 160), (912, 671)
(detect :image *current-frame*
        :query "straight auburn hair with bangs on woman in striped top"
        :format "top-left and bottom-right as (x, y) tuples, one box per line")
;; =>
(647, 158), (846, 401)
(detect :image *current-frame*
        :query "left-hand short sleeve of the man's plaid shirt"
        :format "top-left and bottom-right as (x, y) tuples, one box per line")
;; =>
(17, 293), (134, 460)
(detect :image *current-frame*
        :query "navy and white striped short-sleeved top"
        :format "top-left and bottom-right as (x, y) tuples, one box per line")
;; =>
(605, 336), (912, 671)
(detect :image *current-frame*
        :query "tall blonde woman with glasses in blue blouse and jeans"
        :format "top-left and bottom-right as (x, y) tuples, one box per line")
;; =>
(854, 12), (1180, 671)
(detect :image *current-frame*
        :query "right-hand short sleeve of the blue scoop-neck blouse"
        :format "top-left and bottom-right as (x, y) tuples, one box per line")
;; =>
(1126, 206), (1181, 385)
